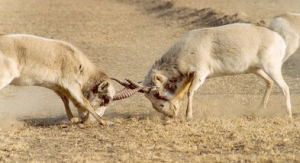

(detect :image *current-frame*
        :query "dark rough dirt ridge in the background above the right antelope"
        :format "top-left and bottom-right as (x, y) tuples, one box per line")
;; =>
(119, 0), (266, 29)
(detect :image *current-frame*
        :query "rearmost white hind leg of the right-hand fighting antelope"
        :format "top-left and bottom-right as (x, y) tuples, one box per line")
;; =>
(266, 67), (293, 119)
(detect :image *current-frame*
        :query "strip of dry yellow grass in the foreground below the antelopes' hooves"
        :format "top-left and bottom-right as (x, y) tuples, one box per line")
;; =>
(0, 116), (300, 162)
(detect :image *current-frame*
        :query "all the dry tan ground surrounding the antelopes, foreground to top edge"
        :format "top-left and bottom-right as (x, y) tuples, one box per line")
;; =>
(0, 0), (300, 162)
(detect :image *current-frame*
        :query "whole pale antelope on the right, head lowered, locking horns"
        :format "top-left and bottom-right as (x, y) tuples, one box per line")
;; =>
(123, 23), (292, 120)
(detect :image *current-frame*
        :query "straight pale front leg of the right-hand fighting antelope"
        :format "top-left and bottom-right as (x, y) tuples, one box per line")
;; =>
(186, 71), (210, 121)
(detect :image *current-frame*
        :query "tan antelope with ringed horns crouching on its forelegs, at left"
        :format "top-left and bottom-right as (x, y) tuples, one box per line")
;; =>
(0, 34), (131, 124)
